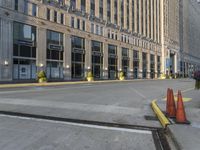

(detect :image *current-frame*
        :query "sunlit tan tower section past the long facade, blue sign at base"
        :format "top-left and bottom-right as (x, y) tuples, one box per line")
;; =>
(161, 0), (180, 74)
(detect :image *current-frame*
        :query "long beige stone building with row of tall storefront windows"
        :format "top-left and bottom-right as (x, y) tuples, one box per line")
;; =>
(0, 0), (179, 81)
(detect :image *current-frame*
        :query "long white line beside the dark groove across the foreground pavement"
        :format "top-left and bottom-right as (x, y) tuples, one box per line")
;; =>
(0, 114), (152, 135)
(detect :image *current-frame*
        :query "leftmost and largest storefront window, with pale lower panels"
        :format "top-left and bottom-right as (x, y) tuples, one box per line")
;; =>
(13, 22), (37, 80)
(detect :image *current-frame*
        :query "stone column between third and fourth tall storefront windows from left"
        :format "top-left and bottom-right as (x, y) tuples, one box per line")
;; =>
(85, 39), (92, 77)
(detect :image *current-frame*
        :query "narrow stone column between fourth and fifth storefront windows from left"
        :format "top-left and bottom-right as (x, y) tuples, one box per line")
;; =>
(103, 43), (108, 79)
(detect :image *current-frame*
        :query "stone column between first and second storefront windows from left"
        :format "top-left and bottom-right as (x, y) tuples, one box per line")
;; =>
(36, 27), (47, 71)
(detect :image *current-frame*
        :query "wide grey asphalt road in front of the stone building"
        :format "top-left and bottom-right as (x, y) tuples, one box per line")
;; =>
(0, 79), (194, 150)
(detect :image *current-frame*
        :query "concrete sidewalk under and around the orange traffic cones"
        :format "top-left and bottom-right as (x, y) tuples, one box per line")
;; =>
(157, 90), (200, 150)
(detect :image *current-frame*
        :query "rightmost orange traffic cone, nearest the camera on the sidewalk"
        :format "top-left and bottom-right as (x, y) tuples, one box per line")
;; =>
(176, 91), (190, 124)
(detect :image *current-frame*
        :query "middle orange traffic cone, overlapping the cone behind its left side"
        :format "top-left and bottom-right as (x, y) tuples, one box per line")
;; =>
(167, 89), (176, 118)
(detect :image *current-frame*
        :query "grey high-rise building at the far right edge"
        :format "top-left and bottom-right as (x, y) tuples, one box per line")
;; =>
(180, 0), (200, 76)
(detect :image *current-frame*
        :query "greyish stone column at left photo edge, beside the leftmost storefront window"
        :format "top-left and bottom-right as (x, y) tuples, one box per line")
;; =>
(0, 18), (13, 81)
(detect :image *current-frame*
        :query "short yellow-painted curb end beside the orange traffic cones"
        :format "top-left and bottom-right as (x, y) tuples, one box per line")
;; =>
(151, 100), (170, 128)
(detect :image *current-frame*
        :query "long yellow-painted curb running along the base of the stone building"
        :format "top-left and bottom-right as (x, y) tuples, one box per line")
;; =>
(0, 79), (159, 89)
